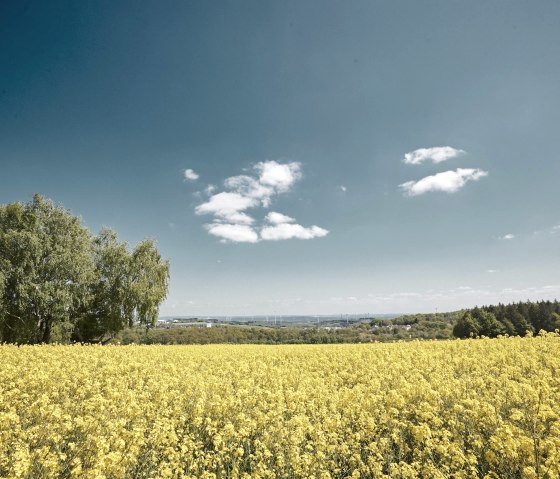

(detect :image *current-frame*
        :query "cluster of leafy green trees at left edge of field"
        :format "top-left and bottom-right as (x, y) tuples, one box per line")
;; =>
(0, 195), (169, 343)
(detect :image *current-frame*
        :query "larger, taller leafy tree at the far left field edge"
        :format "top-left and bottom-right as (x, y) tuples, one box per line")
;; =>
(0, 195), (93, 343)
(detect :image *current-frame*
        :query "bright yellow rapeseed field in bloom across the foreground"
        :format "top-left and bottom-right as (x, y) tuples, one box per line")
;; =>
(0, 334), (560, 479)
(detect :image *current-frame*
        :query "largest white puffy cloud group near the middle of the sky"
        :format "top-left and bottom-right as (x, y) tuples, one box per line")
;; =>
(195, 161), (328, 243)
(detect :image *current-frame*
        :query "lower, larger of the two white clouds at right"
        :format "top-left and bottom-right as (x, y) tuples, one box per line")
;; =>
(399, 168), (488, 196)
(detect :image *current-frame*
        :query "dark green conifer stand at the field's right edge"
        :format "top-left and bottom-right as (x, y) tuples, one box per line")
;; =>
(453, 301), (560, 338)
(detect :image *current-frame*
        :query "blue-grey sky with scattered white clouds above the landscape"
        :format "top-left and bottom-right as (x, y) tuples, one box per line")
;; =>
(0, 0), (560, 316)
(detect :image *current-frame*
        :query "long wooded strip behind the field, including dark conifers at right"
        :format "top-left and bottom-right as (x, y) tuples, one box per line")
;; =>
(114, 301), (560, 344)
